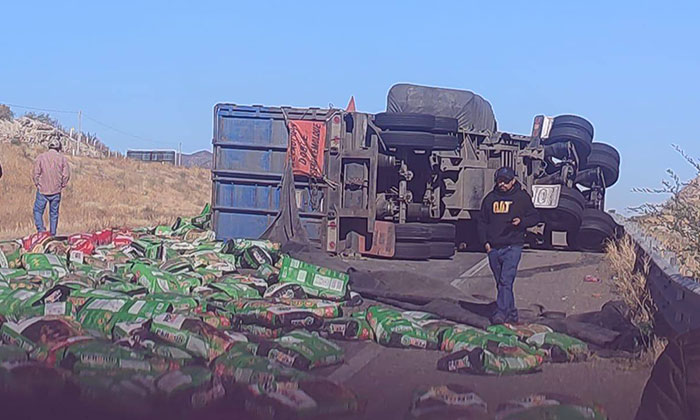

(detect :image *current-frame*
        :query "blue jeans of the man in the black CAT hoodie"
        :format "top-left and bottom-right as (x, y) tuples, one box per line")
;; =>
(488, 245), (523, 322)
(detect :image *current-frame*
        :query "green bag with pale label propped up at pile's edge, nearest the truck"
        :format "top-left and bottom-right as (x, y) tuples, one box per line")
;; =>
(279, 255), (350, 301)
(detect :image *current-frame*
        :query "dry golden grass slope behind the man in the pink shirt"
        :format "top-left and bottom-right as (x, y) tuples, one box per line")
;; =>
(0, 143), (211, 240)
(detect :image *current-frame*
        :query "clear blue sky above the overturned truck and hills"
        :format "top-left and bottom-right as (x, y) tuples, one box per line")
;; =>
(0, 1), (700, 210)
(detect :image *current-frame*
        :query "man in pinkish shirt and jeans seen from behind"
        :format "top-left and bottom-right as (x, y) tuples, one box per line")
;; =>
(32, 137), (70, 236)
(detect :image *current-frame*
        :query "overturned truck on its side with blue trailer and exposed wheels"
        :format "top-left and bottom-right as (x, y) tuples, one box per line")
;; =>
(212, 84), (619, 259)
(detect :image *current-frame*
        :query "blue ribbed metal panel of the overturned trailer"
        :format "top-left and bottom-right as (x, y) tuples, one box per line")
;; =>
(212, 104), (328, 240)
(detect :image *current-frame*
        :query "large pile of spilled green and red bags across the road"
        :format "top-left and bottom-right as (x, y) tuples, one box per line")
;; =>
(0, 206), (600, 417)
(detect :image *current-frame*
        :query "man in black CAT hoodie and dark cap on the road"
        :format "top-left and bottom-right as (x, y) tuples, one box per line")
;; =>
(478, 166), (540, 324)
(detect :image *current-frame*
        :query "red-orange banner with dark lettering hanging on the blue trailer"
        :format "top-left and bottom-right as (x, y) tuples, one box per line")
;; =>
(289, 120), (326, 178)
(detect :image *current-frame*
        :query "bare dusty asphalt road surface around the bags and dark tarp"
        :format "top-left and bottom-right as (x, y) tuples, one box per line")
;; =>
(315, 250), (650, 420)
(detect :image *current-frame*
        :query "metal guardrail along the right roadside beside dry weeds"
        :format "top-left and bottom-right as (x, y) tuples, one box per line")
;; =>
(612, 214), (700, 335)
